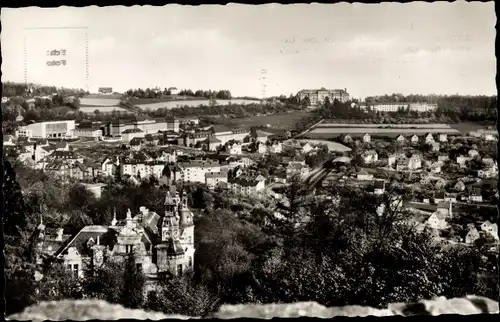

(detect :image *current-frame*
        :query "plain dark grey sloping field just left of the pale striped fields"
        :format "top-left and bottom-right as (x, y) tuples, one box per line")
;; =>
(214, 111), (310, 130)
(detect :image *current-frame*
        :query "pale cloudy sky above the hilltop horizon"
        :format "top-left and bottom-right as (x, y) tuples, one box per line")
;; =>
(0, 1), (497, 98)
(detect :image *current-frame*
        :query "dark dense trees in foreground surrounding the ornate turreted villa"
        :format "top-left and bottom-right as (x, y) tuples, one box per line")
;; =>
(3, 160), (499, 316)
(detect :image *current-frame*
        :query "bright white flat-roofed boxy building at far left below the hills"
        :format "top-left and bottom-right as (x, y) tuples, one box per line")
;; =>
(16, 120), (75, 139)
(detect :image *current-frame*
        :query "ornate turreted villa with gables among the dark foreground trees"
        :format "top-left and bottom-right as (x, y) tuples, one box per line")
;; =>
(37, 186), (195, 288)
